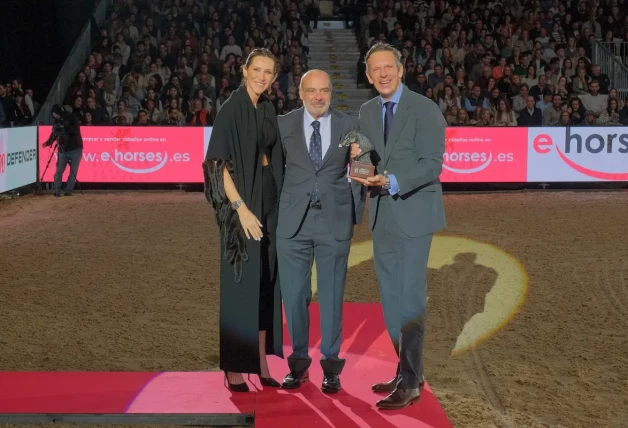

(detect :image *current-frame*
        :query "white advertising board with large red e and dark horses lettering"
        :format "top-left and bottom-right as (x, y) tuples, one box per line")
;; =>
(527, 126), (628, 182)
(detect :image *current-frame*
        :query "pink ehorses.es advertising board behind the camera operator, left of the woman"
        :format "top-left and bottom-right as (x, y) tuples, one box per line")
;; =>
(39, 126), (205, 183)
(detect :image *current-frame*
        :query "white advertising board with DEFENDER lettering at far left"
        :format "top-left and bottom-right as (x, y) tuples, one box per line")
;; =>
(0, 126), (37, 193)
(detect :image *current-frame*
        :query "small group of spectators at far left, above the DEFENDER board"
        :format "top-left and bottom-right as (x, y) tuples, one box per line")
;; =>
(0, 79), (40, 128)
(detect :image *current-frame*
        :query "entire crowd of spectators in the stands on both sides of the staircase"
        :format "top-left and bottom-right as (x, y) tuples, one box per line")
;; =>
(12, 0), (628, 130)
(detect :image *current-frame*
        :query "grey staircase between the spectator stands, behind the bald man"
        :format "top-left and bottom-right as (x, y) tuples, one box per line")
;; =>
(308, 29), (373, 117)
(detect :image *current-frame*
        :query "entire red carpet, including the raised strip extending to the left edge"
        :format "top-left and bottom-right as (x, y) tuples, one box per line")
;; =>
(0, 304), (451, 428)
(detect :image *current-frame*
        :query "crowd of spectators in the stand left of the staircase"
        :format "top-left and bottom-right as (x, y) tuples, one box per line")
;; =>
(64, 0), (318, 126)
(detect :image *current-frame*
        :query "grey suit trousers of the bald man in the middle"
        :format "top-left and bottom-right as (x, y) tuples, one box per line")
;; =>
(277, 208), (351, 374)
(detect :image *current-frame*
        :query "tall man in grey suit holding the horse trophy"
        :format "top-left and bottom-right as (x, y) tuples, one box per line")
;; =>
(348, 43), (446, 409)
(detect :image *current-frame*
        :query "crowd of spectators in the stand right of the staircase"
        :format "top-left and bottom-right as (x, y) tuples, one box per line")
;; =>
(358, 0), (628, 126)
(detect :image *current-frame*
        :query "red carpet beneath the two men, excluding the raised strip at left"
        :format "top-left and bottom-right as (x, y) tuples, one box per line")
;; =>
(255, 303), (452, 428)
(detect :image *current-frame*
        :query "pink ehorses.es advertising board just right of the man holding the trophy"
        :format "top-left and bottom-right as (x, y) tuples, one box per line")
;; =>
(440, 127), (528, 183)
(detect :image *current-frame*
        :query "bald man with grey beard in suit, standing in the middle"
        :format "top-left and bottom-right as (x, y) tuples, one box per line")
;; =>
(277, 70), (366, 393)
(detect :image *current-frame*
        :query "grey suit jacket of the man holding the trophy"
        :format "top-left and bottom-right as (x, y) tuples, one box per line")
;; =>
(359, 86), (447, 237)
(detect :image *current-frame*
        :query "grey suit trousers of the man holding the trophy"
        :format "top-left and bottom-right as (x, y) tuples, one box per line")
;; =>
(373, 196), (433, 389)
